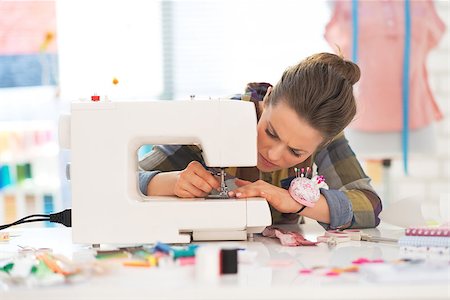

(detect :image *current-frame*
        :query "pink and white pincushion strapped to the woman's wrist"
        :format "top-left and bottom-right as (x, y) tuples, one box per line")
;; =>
(289, 177), (320, 207)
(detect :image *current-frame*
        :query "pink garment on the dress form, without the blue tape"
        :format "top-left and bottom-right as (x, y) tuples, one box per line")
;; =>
(325, 0), (445, 132)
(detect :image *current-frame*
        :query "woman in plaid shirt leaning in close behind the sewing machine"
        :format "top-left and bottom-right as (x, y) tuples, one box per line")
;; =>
(139, 53), (382, 229)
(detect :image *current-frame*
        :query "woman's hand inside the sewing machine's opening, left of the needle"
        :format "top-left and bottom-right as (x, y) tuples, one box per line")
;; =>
(173, 161), (220, 198)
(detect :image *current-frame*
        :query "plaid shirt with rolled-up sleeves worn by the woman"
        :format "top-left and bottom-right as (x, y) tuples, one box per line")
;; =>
(139, 83), (382, 229)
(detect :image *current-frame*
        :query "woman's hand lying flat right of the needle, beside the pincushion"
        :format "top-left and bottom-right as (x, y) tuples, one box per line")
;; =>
(228, 179), (302, 213)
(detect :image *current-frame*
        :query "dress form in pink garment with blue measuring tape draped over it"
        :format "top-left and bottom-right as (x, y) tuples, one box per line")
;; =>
(325, 0), (445, 164)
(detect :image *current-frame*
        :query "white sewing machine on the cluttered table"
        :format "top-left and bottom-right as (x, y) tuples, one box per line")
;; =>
(59, 100), (272, 244)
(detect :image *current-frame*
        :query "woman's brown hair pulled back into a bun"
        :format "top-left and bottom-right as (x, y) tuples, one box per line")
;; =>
(265, 53), (361, 146)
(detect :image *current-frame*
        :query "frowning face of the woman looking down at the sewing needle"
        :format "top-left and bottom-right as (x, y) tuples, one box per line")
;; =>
(257, 100), (323, 172)
